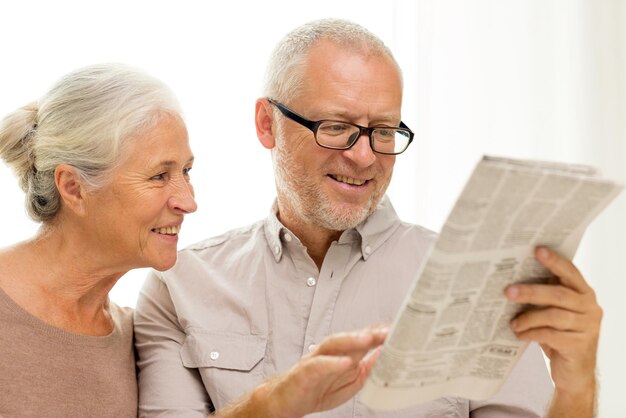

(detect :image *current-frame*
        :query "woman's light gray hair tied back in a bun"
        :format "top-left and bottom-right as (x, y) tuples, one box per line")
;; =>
(0, 64), (181, 222)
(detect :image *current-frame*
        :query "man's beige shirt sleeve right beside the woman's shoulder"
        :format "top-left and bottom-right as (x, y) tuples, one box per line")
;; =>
(135, 272), (212, 417)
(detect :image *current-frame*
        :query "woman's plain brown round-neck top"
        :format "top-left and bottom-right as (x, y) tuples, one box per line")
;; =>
(0, 289), (137, 418)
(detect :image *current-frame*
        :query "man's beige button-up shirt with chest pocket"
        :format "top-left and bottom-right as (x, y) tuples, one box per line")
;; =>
(135, 198), (552, 418)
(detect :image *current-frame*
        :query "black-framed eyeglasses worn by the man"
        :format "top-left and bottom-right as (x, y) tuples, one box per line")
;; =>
(267, 98), (415, 155)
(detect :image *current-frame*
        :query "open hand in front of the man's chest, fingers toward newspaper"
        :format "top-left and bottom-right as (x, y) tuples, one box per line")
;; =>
(218, 327), (387, 418)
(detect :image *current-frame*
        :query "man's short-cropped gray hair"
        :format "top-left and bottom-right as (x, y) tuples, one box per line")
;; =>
(263, 19), (402, 103)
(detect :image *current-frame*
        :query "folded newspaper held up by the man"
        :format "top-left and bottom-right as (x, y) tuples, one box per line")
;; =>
(361, 157), (622, 409)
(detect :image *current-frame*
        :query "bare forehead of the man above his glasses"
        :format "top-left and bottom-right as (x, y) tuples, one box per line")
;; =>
(296, 40), (402, 118)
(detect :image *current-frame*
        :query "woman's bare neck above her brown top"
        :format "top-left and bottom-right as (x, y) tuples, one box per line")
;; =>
(0, 228), (125, 335)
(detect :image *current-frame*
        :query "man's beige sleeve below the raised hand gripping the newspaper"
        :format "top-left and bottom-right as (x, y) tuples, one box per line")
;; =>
(469, 343), (554, 418)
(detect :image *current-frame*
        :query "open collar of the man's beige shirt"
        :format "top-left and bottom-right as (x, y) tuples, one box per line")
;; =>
(264, 195), (400, 262)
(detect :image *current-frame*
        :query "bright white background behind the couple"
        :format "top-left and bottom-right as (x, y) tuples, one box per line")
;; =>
(0, 0), (626, 418)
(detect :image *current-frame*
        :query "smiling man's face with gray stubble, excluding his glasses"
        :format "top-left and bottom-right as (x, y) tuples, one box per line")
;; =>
(273, 40), (402, 231)
